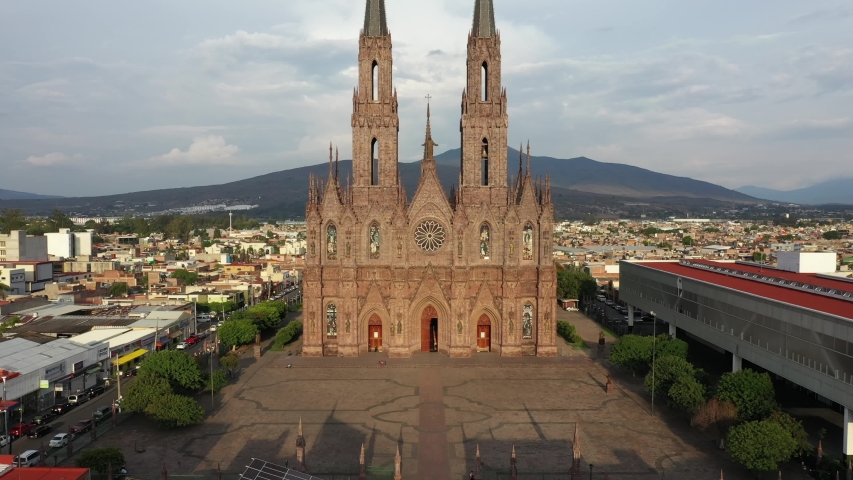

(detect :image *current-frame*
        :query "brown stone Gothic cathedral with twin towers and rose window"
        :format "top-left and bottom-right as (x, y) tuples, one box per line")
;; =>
(302, 0), (558, 357)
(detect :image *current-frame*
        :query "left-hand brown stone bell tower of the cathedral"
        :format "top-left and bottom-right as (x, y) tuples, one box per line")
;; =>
(352, 0), (400, 206)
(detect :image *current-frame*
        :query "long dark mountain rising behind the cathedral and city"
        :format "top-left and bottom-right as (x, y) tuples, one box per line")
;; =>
(0, 148), (759, 218)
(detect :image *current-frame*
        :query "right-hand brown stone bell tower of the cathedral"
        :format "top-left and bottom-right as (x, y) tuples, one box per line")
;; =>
(460, 0), (509, 204)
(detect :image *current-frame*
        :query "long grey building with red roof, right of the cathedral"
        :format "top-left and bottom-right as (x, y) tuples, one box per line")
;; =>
(619, 252), (853, 455)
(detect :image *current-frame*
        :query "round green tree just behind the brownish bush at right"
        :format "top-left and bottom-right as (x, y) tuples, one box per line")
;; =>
(717, 368), (779, 421)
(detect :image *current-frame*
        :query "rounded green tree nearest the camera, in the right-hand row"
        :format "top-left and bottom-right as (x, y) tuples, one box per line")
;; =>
(728, 420), (797, 472)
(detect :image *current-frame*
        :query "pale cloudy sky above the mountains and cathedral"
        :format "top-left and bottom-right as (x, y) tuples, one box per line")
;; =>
(0, 0), (853, 196)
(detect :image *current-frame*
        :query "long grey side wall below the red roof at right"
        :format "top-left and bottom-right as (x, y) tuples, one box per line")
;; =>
(620, 262), (853, 408)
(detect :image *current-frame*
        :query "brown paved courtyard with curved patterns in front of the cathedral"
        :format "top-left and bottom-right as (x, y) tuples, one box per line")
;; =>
(85, 318), (746, 480)
